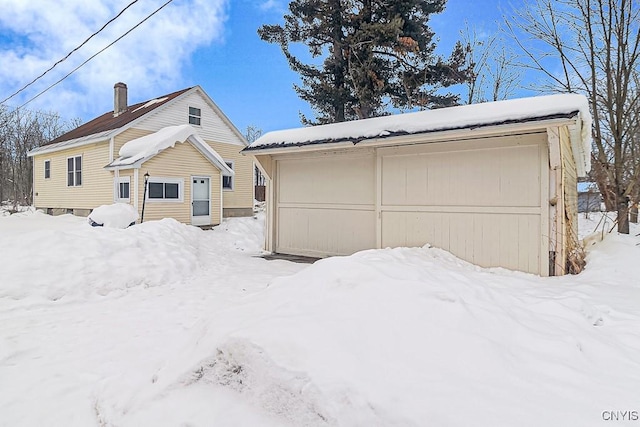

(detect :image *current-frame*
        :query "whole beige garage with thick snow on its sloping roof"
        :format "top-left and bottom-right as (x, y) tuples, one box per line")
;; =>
(244, 95), (591, 276)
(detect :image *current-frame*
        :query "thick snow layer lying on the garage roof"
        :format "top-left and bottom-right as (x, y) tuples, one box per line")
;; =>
(244, 94), (591, 171)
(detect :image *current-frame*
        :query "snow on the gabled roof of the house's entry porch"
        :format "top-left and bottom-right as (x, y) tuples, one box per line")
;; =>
(105, 125), (233, 176)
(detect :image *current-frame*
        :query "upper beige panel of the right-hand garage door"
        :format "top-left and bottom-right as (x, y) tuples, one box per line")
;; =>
(382, 144), (540, 206)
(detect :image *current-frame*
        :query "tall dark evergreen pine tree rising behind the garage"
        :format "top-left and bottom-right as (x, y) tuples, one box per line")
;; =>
(258, 0), (468, 124)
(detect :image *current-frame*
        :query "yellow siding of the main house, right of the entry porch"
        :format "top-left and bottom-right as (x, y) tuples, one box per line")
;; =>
(207, 141), (253, 208)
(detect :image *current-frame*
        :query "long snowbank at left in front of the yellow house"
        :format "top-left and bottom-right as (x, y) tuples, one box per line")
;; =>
(0, 218), (202, 300)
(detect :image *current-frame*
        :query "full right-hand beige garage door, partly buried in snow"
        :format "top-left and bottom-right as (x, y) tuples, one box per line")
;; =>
(378, 134), (548, 274)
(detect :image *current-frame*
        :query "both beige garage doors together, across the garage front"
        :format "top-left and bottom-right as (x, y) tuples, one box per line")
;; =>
(275, 132), (548, 275)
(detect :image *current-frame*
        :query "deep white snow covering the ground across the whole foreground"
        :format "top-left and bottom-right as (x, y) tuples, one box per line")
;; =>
(0, 211), (640, 426)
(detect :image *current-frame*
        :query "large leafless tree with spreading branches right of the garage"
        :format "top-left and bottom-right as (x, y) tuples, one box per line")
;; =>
(506, 0), (640, 233)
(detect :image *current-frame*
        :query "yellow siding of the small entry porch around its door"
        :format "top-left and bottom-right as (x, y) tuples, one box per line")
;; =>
(131, 142), (221, 224)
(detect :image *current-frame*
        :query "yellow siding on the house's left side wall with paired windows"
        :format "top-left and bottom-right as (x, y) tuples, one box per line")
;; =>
(33, 141), (113, 209)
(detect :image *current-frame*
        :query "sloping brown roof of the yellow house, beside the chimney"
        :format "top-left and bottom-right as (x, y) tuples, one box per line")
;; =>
(43, 87), (192, 146)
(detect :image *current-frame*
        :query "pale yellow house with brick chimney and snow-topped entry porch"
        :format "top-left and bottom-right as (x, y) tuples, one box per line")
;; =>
(29, 83), (254, 225)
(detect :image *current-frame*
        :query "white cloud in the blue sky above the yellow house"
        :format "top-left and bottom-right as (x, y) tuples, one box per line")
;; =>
(0, 0), (227, 118)
